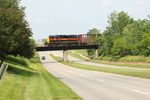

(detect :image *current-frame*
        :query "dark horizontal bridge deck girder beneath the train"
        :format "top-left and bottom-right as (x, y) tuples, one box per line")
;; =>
(36, 45), (98, 51)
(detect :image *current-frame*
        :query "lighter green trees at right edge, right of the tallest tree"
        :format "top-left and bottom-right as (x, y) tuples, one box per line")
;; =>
(120, 20), (150, 56)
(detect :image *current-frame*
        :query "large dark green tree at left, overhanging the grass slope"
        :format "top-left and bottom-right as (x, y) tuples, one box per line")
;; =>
(0, 0), (35, 65)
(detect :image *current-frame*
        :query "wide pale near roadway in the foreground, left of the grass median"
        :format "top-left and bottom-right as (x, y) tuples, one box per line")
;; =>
(39, 52), (150, 100)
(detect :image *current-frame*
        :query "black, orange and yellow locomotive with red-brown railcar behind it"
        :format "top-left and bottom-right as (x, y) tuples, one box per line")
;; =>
(45, 34), (99, 46)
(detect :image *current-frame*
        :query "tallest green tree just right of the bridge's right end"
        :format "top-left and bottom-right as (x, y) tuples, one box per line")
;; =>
(100, 11), (133, 56)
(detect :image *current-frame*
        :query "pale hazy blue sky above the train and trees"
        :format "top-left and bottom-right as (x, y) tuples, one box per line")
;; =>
(21, 0), (150, 39)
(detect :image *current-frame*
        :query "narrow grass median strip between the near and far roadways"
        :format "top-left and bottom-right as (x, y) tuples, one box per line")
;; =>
(50, 55), (150, 78)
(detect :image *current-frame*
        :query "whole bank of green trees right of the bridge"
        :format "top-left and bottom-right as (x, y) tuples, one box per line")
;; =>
(88, 11), (150, 57)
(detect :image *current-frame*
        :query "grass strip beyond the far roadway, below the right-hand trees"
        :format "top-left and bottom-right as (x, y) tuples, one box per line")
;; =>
(69, 50), (150, 69)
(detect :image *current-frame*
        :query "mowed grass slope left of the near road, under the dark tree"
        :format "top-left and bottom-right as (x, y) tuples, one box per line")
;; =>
(0, 55), (81, 100)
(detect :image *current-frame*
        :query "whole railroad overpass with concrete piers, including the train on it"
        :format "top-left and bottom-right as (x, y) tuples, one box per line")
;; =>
(36, 34), (101, 61)
